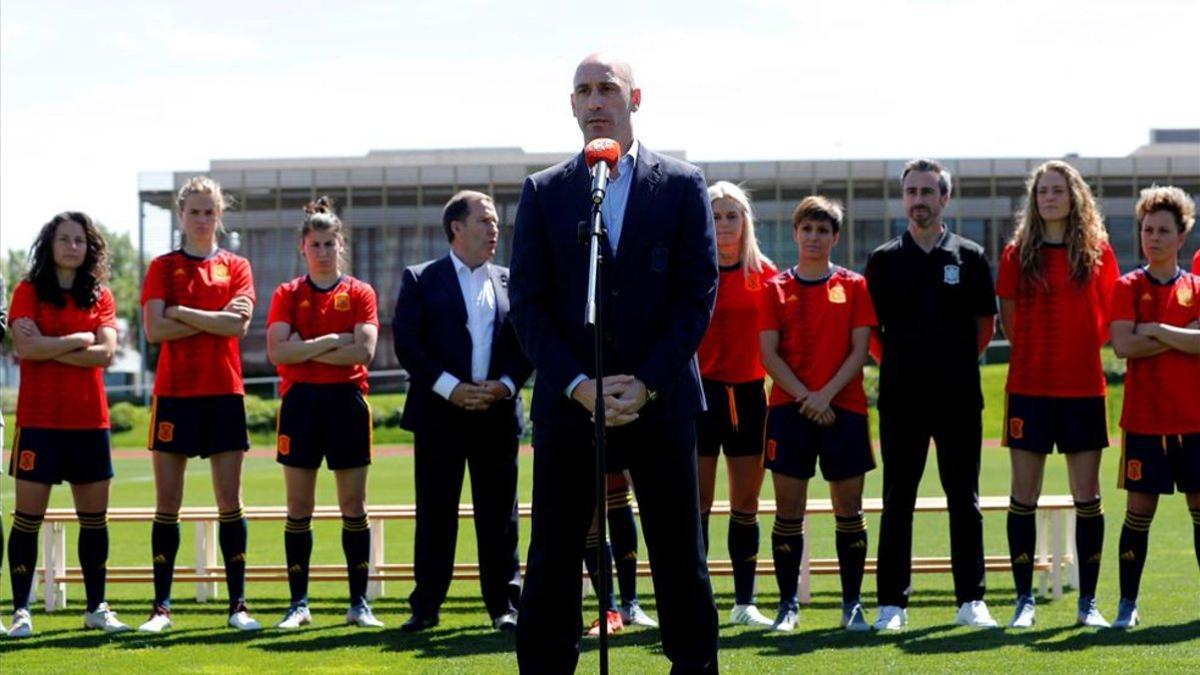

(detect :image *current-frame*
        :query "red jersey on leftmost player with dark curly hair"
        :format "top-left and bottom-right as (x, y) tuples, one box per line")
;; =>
(8, 281), (116, 429)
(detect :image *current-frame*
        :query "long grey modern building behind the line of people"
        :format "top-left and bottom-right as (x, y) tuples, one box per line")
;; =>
(139, 130), (1200, 372)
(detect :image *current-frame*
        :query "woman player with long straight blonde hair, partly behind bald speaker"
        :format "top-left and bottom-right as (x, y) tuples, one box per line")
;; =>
(696, 180), (778, 626)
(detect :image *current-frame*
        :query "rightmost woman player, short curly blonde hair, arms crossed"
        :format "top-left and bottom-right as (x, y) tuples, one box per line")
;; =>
(1112, 186), (1200, 628)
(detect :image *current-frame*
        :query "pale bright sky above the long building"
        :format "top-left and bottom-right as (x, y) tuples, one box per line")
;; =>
(0, 0), (1200, 249)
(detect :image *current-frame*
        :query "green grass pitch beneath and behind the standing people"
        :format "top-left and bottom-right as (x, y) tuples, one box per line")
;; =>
(0, 366), (1200, 674)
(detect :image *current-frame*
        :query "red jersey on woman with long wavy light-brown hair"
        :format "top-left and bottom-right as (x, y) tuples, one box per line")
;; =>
(996, 243), (1121, 398)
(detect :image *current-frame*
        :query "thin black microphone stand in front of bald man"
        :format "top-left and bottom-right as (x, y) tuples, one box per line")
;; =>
(583, 183), (610, 675)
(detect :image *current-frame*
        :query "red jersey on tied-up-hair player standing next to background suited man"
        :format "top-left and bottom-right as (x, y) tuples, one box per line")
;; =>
(266, 275), (379, 395)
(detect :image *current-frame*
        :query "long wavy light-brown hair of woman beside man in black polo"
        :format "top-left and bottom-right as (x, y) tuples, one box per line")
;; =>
(1013, 160), (1109, 285)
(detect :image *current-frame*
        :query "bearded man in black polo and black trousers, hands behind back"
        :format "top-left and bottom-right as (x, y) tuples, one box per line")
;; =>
(866, 160), (996, 631)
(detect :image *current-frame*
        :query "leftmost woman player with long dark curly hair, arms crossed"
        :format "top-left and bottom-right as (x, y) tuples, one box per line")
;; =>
(8, 211), (130, 638)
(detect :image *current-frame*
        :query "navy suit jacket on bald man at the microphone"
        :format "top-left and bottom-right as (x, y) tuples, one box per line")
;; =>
(511, 145), (719, 424)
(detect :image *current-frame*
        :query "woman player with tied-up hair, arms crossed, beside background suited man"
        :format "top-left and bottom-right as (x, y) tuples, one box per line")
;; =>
(266, 197), (383, 629)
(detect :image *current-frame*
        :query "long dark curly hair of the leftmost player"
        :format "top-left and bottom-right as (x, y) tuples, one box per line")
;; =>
(25, 211), (109, 309)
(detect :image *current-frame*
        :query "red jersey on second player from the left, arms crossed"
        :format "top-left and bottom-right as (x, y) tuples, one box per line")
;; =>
(142, 250), (254, 396)
